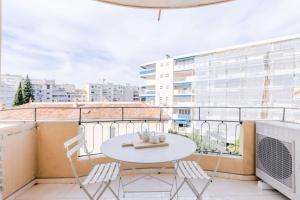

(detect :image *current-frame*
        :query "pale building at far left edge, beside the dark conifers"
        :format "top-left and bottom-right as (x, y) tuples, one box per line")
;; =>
(0, 74), (23, 107)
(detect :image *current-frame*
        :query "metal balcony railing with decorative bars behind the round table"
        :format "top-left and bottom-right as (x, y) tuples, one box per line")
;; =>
(0, 106), (300, 155)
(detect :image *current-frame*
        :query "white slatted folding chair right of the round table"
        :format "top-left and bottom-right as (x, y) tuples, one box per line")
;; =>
(171, 131), (226, 200)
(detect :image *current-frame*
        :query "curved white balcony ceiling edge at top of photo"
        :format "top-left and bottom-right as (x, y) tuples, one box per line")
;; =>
(97, 0), (231, 9)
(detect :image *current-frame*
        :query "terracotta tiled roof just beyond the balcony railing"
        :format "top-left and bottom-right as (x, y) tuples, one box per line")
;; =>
(0, 102), (169, 121)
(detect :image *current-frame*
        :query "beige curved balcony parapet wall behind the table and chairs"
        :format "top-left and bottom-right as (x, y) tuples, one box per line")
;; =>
(37, 122), (255, 178)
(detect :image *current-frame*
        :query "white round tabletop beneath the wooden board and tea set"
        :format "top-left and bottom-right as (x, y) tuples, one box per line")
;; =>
(101, 134), (196, 164)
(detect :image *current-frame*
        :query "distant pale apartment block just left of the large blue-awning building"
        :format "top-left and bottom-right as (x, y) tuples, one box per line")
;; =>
(87, 82), (139, 102)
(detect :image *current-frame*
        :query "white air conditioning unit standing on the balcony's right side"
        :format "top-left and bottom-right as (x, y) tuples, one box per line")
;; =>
(256, 121), (300, 200)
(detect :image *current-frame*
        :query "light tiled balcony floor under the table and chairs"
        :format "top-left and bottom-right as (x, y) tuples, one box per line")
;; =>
(17, 175), (287, 200)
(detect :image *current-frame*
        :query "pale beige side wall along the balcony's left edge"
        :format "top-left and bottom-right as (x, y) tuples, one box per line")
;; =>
(0, 123), (36, 198)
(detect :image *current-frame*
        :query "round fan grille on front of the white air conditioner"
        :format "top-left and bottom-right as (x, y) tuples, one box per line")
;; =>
(256, 134), (294, 189)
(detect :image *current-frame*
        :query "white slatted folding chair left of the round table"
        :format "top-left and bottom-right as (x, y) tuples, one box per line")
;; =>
(64, 128), (120, 200)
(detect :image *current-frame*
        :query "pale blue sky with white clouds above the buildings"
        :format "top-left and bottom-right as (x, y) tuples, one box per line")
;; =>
(1, 0), (300, 87)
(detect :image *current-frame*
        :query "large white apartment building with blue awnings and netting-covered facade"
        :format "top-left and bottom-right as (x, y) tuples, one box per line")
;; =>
(140, 35), (300, 125)
